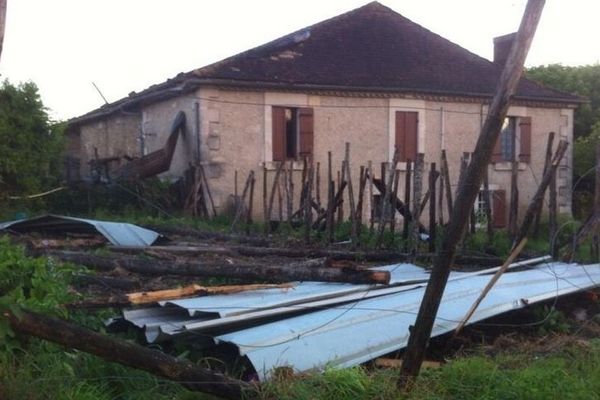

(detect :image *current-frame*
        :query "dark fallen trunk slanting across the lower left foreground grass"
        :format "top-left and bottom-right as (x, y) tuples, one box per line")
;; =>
(8, 311), (254, 399)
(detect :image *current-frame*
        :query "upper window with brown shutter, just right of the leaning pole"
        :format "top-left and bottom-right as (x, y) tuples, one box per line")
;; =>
(492, 117), (531, 163)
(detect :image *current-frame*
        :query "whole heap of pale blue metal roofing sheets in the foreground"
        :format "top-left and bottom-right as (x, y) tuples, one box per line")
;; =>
(118, 258), (600, 379)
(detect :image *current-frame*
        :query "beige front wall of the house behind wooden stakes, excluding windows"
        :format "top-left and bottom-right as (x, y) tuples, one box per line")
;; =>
(198, 89), (573, 220)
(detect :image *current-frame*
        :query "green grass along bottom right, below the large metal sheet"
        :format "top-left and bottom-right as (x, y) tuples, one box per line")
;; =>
(261, 339), (600, 400)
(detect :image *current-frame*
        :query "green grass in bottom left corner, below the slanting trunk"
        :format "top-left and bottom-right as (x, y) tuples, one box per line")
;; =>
(0, 340), (214, 400)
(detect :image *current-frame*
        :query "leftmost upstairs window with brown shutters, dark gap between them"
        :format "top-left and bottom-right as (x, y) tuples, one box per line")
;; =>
(272, 106), (314, 161)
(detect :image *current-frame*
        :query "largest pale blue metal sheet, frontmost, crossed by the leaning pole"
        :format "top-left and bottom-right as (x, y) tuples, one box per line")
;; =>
(216, 263), (600, 379)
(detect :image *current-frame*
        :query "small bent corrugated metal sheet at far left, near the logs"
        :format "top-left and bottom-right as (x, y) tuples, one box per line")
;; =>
(0, 214), (160, 247)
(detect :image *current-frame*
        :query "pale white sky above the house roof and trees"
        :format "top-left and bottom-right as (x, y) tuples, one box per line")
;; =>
(0, 0), (600, 119)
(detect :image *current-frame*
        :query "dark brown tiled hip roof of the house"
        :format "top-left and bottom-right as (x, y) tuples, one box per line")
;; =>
(72, 2), (583, 122)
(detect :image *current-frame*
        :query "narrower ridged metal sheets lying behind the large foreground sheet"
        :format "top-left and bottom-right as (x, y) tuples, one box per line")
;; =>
(123, 257), (549, 342)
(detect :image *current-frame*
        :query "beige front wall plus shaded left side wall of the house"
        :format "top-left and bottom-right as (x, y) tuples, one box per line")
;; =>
(72, 87), (573, 225)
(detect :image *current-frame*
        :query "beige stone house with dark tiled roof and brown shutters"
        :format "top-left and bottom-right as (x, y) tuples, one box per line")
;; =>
(68, 2), (582, 226)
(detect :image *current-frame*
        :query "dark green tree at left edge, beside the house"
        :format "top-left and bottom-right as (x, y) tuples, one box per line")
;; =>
(0, 80), (64, 195)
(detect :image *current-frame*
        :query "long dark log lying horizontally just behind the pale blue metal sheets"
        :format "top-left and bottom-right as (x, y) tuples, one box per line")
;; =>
(45, 251), (390, 284)
